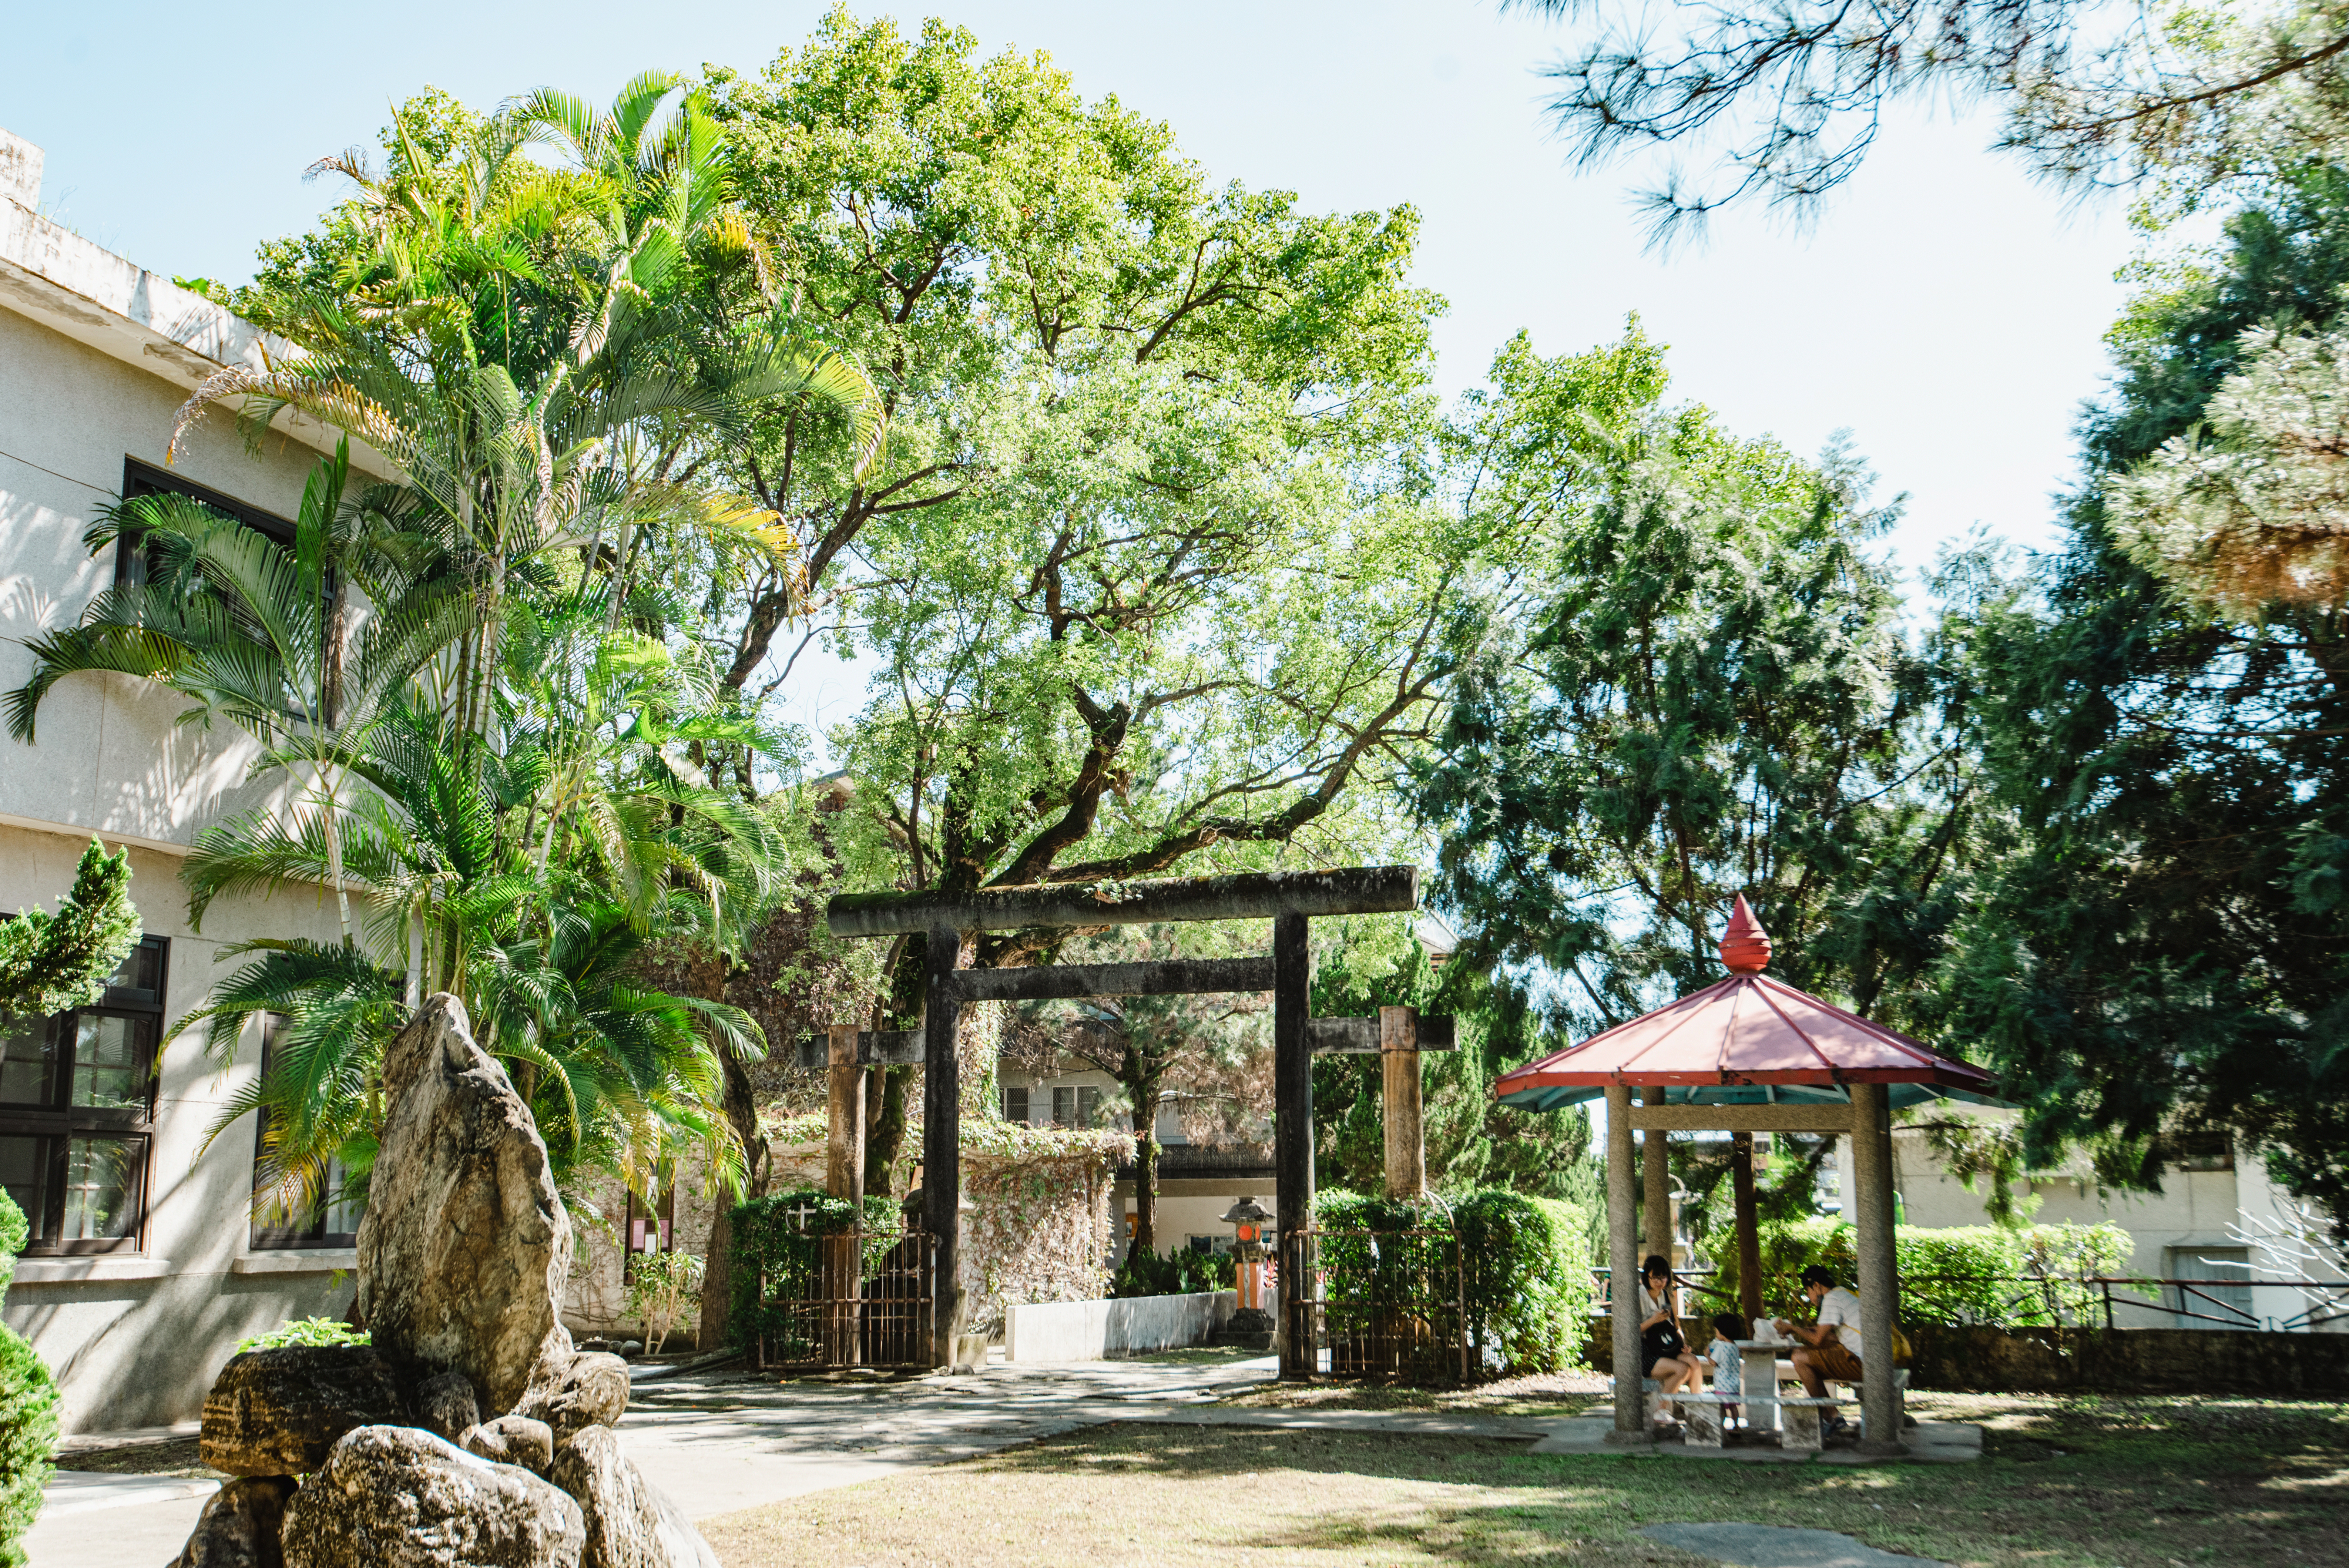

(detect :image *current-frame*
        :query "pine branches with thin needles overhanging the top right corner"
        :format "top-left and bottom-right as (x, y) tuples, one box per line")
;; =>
(1503, 0), (2349, 235)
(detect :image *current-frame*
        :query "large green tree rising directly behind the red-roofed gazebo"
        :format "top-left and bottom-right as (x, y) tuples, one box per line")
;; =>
(1417, 331), (1983, 1028)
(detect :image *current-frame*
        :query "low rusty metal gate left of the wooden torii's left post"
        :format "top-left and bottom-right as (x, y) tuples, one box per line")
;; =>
(756, 1230), (938, 1371)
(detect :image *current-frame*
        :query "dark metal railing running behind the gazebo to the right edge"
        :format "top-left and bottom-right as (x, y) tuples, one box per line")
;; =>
(1591, 1267), (2349, 1333)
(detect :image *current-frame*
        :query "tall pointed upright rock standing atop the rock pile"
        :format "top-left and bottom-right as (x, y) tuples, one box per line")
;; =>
(360, 995), (571, 1411)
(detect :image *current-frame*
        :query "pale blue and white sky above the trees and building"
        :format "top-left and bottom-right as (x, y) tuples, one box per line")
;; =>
(0, 0), (2133, 746)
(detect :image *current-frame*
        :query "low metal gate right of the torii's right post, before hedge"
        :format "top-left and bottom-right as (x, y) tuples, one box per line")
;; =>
(1280, 1230), (1468, 1387)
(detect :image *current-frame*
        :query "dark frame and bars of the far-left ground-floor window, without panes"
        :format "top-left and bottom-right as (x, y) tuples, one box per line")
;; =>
(0, 939), (172, 1258)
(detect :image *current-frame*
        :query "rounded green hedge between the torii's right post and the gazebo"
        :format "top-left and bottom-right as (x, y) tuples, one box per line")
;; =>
(1313, 1187), (1591, 1373)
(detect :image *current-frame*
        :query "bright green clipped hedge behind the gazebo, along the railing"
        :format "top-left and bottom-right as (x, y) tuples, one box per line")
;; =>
(1689, 1216), (2131, 1328)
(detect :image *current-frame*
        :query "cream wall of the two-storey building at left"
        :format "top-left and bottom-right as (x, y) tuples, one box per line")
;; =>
(0, 175), (355, 1432)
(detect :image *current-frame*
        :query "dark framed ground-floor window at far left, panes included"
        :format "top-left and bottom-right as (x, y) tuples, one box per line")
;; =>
(0, 936), (172, 1256)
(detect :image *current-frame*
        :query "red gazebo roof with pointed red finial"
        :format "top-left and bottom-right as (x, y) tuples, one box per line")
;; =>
(1494, 894), (1997, 1110)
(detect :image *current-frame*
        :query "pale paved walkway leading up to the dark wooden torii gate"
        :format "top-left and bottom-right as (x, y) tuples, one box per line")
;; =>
(26, 1357), (1980, 1568)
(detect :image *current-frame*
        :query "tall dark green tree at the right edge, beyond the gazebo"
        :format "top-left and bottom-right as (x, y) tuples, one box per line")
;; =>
(1945, 167), (2349, 1220)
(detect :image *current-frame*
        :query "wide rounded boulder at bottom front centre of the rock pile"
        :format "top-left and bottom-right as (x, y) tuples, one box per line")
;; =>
(284, 1427), (587, 1568)
